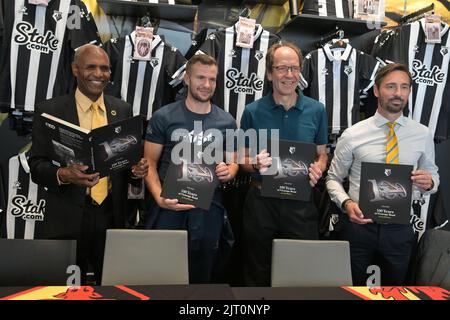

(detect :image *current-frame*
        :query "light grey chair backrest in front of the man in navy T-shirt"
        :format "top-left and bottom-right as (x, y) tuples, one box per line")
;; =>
(102, 230), (189, 285)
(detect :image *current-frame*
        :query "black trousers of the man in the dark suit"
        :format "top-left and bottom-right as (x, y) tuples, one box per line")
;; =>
(77, 195), (113, 285)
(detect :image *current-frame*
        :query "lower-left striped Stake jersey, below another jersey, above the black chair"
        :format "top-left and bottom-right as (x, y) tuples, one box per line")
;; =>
(0, 153), (47, 239)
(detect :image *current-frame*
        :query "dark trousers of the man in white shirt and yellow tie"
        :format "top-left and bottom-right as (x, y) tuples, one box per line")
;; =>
(340, 216), (415, 286)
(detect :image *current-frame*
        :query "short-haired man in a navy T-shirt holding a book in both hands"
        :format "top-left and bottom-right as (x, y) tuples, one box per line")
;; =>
(144, 54), (239, 283)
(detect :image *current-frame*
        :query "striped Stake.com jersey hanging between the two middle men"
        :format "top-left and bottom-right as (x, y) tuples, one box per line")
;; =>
(198, 23), (280, 125)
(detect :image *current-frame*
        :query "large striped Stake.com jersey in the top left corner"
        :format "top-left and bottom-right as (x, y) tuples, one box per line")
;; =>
(0, 0), (100, 112)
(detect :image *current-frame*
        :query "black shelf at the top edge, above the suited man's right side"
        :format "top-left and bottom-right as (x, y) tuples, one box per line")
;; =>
(97, 0), (197, 21)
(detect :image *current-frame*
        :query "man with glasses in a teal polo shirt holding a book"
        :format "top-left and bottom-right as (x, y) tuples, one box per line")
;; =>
(241, 42), (328, 286)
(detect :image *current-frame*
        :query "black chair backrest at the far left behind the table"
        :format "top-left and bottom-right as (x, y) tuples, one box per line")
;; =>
(0, 239), (77, 286)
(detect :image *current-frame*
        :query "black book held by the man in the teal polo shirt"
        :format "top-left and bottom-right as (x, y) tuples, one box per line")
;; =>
(261, 140), (317, 201)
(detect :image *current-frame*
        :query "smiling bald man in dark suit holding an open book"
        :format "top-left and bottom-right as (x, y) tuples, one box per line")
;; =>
(29, 45), (148, 284)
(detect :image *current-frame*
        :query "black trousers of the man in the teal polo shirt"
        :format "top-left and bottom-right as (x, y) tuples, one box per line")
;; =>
(243, 187), (319, 287)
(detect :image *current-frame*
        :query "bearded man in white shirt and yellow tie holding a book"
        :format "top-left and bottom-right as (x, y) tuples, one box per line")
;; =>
(327, 64), (439, 286)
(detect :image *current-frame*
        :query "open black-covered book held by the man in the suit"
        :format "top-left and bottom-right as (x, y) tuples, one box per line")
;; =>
(42, 113), (143, 177)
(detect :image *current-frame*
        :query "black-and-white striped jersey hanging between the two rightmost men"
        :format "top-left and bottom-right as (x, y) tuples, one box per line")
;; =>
(300, 44), (380, 134)
